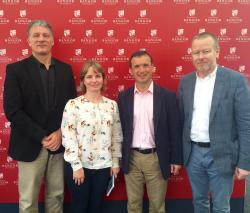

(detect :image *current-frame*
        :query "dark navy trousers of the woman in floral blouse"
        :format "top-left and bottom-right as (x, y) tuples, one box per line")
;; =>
(65, 163), (110, 213)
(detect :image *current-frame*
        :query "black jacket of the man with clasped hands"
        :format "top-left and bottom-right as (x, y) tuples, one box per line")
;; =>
(3, 56), (76, 162)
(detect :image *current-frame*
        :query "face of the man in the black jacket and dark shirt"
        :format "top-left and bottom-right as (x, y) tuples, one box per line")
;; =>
(28, 26), (54, 56)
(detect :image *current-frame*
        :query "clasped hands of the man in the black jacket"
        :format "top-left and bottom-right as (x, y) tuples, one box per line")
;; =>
(42, 129), (62, 151)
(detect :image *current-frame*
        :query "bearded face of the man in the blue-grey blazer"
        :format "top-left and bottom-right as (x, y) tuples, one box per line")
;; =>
(192, 37), (219, 76)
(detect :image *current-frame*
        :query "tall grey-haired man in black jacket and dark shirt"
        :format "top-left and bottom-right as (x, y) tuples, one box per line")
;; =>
(4, 20), (76, 213)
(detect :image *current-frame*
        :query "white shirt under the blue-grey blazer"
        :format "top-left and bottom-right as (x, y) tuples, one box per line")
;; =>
(190, 67), (217, 142)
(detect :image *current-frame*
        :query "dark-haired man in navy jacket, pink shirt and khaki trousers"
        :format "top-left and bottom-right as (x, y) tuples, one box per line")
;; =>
(118, 51), (182, 213)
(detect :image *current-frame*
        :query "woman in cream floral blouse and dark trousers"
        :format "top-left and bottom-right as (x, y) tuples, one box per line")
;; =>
(61, 61), (122, 213)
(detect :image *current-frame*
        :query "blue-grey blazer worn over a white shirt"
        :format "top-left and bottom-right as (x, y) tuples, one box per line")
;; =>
(179, 66), (250, 174)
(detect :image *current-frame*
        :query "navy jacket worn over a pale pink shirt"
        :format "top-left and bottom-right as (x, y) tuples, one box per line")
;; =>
(118, 84), (182, 179)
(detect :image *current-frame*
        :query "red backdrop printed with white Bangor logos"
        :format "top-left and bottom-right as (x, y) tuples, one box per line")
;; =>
(0, 0), (250, 203)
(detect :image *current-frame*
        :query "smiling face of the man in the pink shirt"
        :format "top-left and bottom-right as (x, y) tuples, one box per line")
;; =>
(129, 55), (155, 85)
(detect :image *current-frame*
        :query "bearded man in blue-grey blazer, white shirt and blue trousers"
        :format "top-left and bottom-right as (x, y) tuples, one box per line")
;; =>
(179, 32), (250, 213)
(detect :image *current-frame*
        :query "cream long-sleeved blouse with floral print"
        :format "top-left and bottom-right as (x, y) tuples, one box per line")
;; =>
(61, 96), (122, 171)
